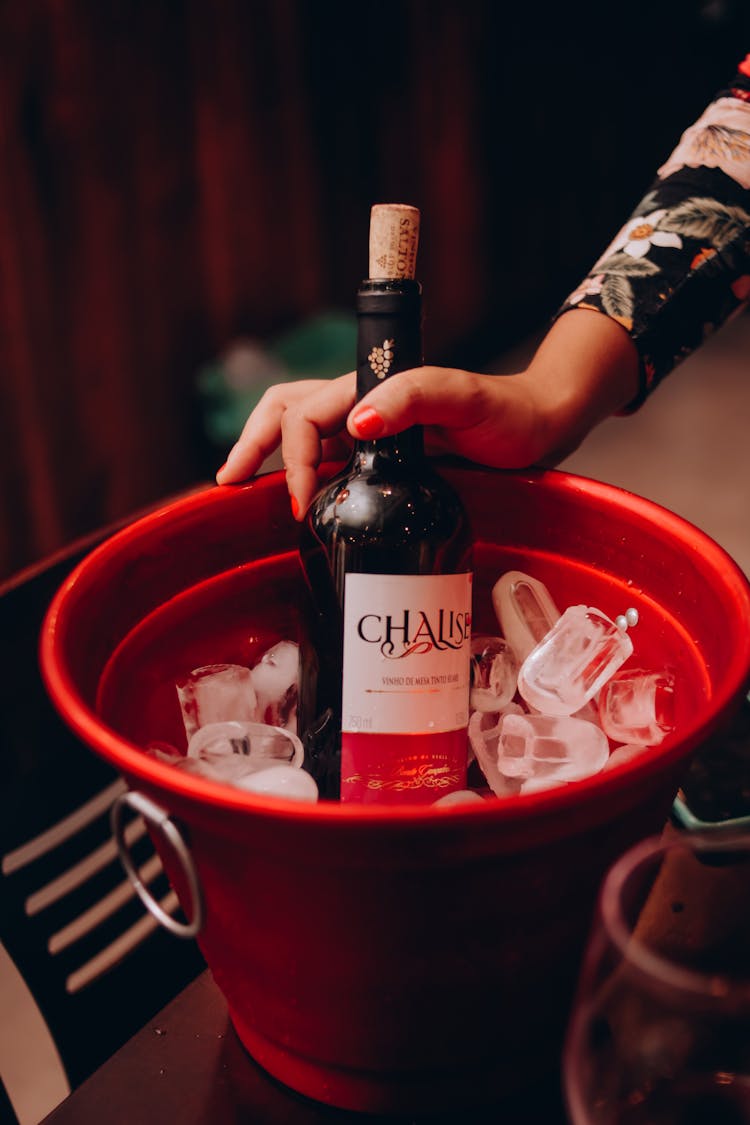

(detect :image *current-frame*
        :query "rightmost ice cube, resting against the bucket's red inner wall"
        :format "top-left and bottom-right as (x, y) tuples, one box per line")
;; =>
(599, 668), (675, 746)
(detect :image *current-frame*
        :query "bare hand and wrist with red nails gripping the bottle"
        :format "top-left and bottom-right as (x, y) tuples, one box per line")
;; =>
(217, 309), (638, 519)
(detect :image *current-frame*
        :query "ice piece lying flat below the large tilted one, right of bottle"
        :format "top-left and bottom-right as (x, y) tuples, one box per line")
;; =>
(497, 714), (609, 782)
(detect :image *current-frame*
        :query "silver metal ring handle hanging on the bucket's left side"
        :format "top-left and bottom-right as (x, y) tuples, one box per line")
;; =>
(110, 790), (205, 938)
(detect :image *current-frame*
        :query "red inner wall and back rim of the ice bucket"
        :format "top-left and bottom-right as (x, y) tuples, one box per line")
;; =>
(43, 467), (750, 815)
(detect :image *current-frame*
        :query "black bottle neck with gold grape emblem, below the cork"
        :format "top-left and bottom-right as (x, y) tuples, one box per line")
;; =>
(354, 278), (424, 461)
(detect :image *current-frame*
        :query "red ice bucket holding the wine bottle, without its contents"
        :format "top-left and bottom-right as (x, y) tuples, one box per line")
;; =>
(42, 467), (750, 1113)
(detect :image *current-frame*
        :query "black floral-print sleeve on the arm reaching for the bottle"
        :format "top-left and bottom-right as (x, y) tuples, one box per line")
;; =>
(558, 55), (750, 411)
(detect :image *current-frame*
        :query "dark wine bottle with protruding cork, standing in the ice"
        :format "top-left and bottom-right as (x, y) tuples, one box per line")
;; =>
(299, 204), (471, 804)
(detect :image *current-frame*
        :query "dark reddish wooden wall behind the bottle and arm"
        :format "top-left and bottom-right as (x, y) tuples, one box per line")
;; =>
(0, 0), (750, 577)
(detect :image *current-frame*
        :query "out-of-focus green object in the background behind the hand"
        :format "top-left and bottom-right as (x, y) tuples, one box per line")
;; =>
(196, 312), (356, 447)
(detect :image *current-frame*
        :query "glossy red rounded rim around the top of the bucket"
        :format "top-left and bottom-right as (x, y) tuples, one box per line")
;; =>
(39, 459), (750, 827)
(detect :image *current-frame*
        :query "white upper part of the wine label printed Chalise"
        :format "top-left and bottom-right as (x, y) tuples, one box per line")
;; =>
(342, 574), (471, 735)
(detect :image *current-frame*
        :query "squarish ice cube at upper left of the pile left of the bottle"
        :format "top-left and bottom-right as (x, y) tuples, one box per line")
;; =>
(177, 664), (256, 739)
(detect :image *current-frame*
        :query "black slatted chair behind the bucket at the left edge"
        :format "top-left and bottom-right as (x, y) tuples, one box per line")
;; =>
(0, 529), (205, 1125)
